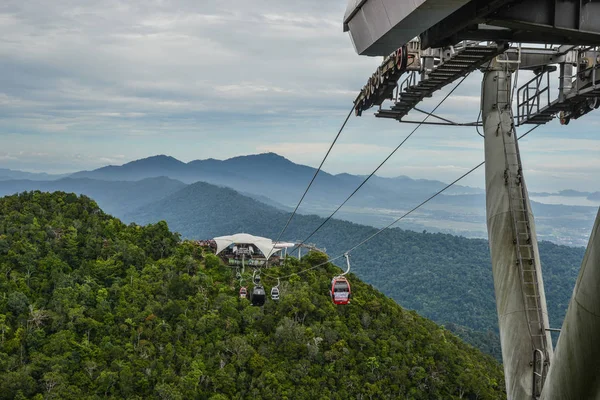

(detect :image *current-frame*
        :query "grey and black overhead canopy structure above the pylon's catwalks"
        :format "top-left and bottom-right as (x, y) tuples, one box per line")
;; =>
(344, 0), (600, 56)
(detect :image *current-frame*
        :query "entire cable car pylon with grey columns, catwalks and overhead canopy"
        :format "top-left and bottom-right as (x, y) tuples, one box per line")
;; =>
(340, 0), (600, 400)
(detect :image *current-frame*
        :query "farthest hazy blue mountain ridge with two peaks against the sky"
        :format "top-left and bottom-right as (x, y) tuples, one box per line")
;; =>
(63, 153), (480, 208)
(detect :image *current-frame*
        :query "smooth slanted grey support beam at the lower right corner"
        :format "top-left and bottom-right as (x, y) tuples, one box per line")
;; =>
(541, 211), (600, 400)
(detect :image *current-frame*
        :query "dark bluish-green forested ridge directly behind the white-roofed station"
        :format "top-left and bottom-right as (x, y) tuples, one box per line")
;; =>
(130, 182), (584, 359)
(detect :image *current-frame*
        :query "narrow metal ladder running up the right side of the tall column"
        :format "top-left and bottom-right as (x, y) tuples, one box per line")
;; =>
(499, 105), (549, 399)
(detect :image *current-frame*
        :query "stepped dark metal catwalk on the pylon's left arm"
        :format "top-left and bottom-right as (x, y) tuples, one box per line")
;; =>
(375, 42), (507, 121)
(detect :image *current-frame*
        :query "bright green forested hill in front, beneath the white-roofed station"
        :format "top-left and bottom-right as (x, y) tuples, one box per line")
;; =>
(0, 192), (505, 399)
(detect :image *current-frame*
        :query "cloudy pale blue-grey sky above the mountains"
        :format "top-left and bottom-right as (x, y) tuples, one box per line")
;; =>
(0, 0), (600, 191)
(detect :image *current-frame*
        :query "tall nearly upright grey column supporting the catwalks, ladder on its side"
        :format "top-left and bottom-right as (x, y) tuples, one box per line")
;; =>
(481, 60), (552, 400)
